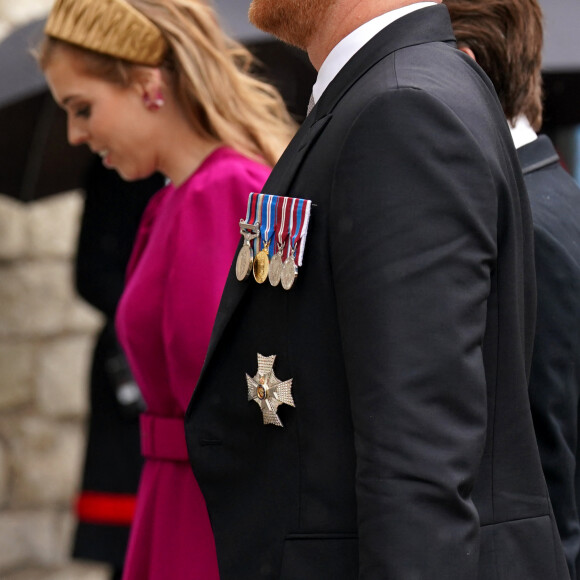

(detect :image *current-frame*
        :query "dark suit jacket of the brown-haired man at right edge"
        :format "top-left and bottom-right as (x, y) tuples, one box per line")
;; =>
(518, 136), (580, 579)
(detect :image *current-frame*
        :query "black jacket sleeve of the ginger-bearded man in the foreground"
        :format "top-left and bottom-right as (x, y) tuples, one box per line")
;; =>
(330, 89), (498, 580)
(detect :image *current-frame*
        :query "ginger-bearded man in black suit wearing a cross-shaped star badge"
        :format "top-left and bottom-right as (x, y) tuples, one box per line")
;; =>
(186, 0), (567, 580)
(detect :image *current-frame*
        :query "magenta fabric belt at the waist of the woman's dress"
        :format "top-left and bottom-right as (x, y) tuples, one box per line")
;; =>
(139, 413), (189, 461)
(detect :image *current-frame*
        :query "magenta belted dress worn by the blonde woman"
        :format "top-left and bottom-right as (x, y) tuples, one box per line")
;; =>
(117, 147), (269, 580)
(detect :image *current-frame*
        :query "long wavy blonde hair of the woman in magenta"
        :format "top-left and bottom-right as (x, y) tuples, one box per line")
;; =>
(39, 0), (296, 166)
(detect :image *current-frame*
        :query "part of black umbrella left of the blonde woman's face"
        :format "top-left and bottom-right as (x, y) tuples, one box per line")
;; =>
(0, 19), (94, 201)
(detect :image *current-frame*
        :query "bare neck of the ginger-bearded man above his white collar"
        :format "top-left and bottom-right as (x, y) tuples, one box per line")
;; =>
(307, 0), (441, 70)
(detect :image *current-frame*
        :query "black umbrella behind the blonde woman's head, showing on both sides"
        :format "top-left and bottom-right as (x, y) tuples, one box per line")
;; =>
(0, 5), (314, 201)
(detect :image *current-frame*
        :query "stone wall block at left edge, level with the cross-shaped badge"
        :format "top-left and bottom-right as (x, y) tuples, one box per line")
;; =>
(0, 341), (34, 411)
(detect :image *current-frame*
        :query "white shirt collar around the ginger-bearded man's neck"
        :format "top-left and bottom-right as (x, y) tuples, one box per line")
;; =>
(312, 2), (436, 103)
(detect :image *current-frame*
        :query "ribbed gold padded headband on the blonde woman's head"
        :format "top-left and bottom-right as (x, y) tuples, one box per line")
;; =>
(44, 0), (167, 66)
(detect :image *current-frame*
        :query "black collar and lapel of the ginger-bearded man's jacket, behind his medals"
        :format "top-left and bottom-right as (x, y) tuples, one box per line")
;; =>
(194, 5), (455, 398)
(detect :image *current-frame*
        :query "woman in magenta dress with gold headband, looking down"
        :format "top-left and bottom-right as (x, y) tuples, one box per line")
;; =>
(39, 0), (294, 580)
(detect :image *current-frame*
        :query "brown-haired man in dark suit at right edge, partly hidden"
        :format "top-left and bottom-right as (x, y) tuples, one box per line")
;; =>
(445, 0), (580, 580)
